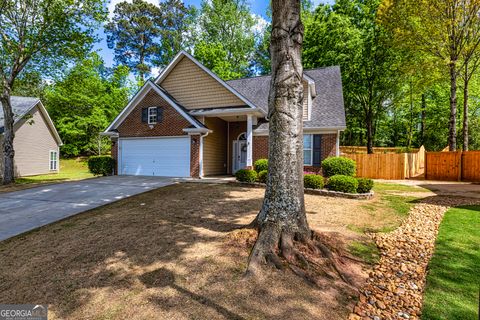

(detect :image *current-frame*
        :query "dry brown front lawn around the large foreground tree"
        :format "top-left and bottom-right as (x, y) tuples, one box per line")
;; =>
(0, 183), (428, 320)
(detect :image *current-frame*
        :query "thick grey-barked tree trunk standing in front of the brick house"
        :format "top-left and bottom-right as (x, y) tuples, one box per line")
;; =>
(247, 0), (311, 273)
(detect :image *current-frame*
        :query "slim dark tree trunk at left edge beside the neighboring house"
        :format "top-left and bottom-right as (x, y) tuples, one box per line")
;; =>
(0, 84), (15, 184)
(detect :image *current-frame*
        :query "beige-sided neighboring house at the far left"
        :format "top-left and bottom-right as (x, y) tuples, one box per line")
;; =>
(0, 97), (62, 177)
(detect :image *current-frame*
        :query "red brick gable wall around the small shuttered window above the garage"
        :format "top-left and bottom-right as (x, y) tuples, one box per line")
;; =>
(117, 90), (191, 137)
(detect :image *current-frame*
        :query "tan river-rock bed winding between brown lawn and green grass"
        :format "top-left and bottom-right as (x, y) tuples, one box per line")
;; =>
(349, 196), (479, 320)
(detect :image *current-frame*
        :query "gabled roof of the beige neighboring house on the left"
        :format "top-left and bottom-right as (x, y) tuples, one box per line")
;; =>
(0, 96), (62, 145)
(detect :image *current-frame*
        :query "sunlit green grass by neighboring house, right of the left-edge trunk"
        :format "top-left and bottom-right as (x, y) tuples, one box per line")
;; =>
(15, 159), (93, 184)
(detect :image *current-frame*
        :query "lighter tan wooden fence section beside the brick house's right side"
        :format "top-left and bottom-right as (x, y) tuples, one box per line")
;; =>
(343, 146), (425, 180)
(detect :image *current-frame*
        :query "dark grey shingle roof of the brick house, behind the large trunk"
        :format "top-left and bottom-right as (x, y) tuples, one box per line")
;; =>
(227, 66), (346, 129)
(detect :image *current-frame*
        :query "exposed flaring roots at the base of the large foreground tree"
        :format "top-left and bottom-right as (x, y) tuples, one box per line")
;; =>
(246, 224), (354, 287)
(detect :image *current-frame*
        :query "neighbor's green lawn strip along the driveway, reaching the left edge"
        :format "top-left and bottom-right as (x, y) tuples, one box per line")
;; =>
(0, 158), (93, 192)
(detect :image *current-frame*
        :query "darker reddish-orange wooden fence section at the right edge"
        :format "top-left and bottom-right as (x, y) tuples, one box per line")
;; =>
(425, 151), (480, 182)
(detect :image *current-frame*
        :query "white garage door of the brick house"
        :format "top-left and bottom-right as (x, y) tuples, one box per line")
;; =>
(119, 137), (190, 177)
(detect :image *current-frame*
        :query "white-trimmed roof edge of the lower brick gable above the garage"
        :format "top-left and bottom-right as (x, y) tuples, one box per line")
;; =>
(104, 80), (205, 133)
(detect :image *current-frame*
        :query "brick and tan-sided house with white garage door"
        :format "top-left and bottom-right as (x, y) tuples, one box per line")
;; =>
(103, 51), (346, 177)
